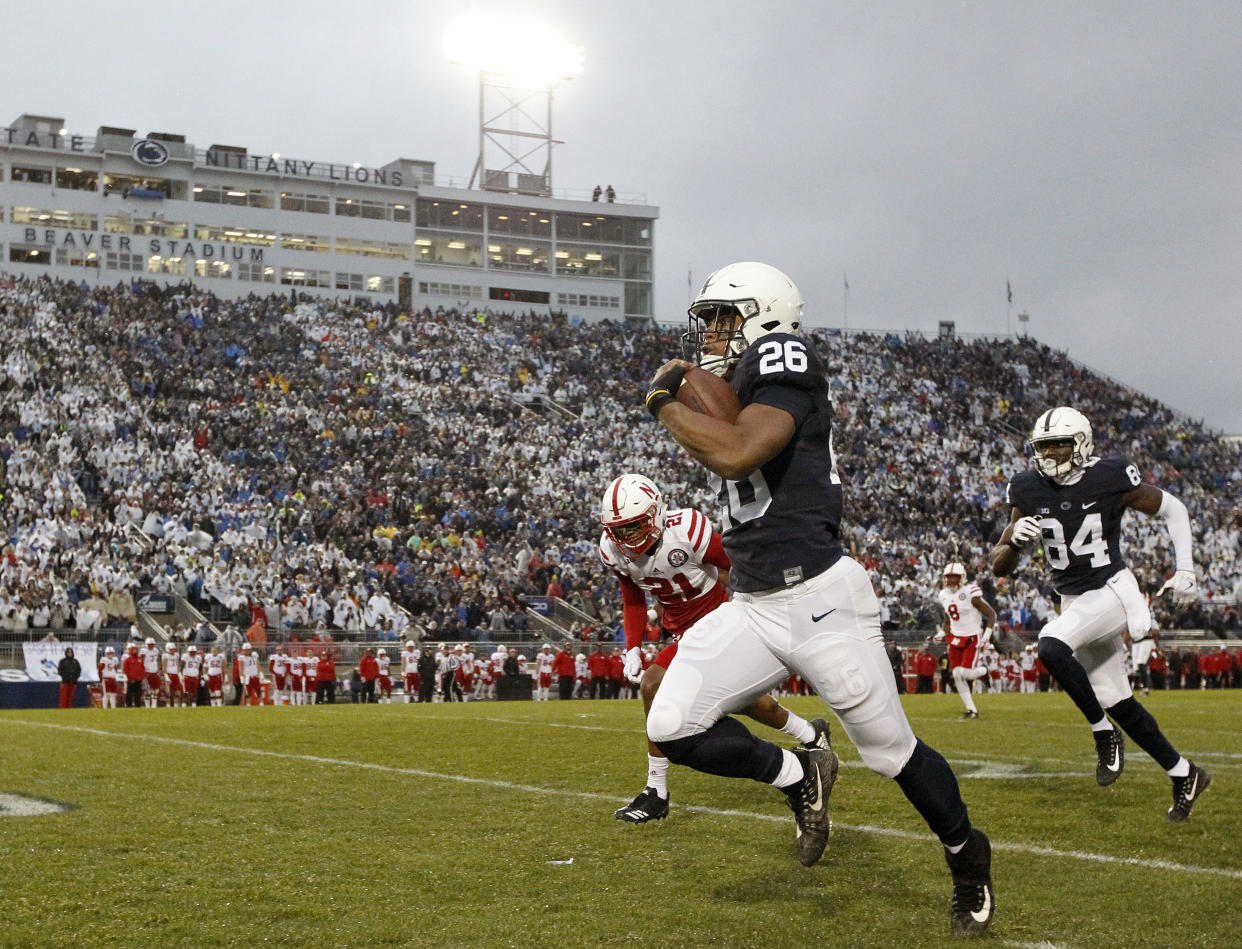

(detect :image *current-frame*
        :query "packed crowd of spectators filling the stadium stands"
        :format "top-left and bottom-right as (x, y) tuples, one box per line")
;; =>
(0, 270), (1242, 641)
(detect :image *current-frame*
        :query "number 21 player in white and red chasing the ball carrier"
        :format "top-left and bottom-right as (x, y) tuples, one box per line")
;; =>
(600, 475), (828, 824)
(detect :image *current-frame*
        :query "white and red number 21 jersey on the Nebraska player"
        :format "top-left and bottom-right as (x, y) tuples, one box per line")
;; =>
(600, 508), (729, 648)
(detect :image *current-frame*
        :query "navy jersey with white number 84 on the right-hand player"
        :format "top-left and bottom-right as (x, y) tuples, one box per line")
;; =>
(1006, 458), (1143, 594)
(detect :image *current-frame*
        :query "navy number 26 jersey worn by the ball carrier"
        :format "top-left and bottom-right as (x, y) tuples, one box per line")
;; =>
(713, 333), (842, 593)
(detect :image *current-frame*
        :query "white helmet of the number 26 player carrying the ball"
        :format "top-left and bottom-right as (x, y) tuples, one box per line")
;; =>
(683, 261), (802, 376)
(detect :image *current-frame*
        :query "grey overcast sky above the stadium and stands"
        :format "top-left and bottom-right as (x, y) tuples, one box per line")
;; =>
(9, 0), (1242, 434)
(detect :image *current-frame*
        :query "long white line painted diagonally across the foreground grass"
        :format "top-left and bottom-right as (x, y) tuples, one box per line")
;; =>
(9, 718), (1242, 884)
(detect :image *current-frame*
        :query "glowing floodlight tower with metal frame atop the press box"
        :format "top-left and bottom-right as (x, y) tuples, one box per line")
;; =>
(445, 14), (582, 195)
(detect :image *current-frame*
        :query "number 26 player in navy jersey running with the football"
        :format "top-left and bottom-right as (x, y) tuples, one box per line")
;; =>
(646, 263), (995, 934)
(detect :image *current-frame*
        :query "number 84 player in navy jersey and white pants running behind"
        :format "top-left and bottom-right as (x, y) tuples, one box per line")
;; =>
(992, 406), (1211, 821)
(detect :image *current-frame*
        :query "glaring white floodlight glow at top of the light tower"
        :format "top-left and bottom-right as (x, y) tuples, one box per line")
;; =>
(445, 12), (582, 89)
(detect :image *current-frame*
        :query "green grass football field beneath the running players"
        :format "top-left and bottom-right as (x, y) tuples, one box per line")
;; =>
(0, 691), (1242, 949)
